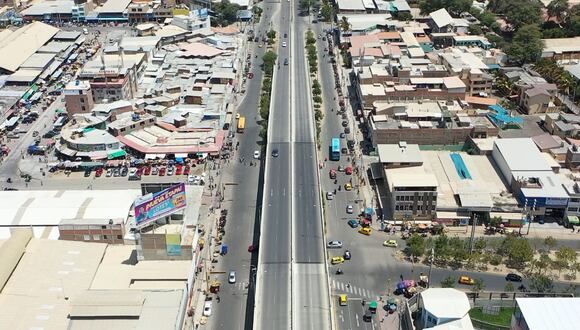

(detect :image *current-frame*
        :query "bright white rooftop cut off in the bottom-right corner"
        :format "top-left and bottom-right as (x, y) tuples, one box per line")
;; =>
(516, 298), (580, 330)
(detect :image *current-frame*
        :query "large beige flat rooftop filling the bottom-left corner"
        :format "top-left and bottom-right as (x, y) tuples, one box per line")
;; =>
(0, 238), (107, 330)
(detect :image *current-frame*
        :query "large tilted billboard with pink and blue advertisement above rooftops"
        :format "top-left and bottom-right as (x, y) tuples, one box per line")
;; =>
(135, 183), (186, 226)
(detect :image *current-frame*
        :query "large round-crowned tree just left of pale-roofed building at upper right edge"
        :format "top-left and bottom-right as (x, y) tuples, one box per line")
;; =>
(505, 24), (544, 65)
